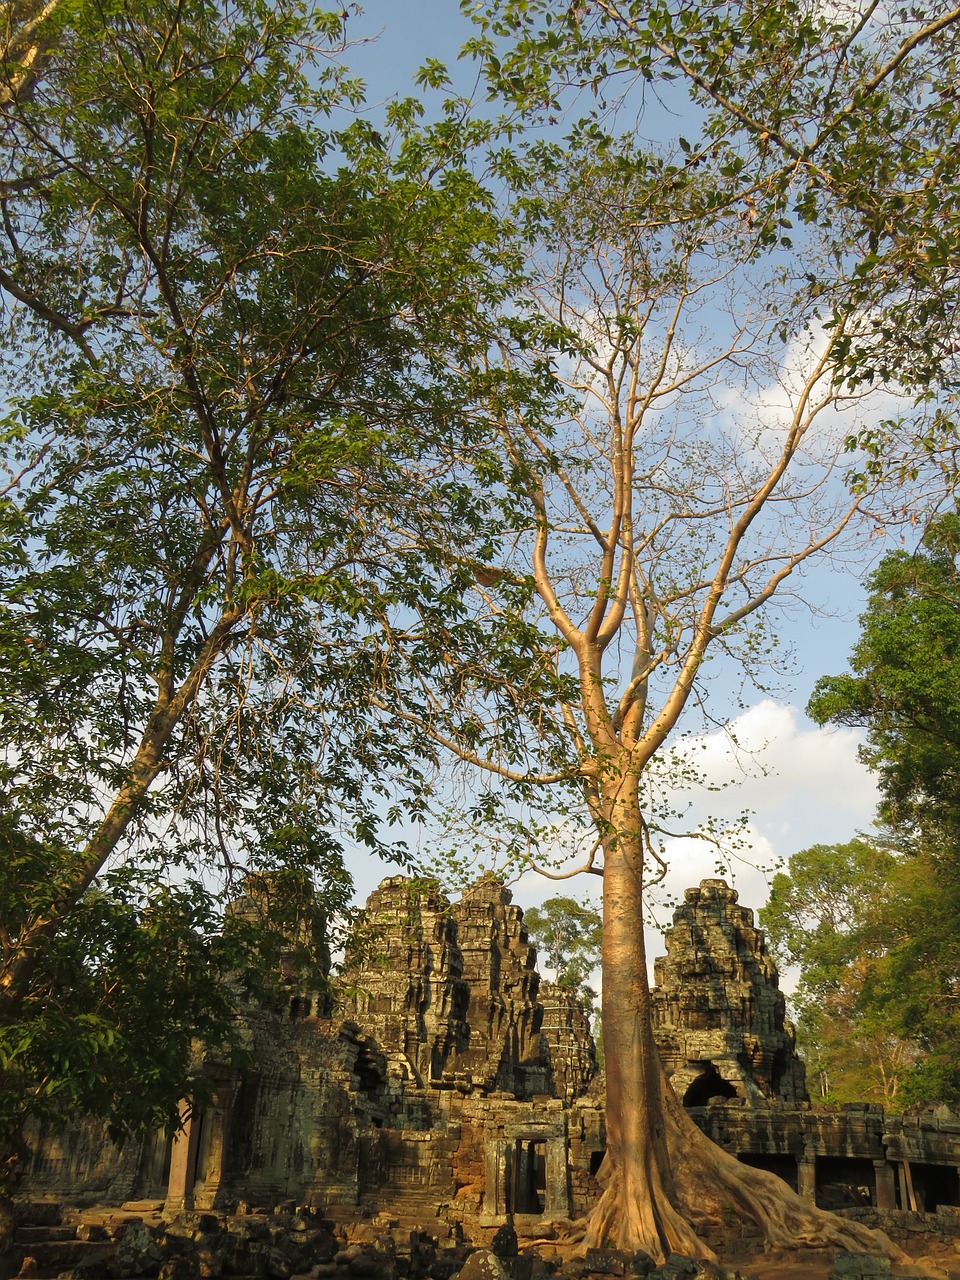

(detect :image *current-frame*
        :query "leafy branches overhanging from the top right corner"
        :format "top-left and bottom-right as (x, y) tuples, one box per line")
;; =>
(475, 0), (960, 480)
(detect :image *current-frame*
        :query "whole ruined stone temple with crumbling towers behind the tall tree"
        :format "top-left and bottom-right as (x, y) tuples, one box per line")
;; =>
(20, 877), (960, 1223)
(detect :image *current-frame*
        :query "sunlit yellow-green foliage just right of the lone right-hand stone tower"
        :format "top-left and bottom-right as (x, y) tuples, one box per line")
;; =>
(760, 840), (960, 1108)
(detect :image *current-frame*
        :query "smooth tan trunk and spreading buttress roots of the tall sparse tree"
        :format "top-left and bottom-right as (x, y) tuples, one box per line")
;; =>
(585, 780), (904, 1262)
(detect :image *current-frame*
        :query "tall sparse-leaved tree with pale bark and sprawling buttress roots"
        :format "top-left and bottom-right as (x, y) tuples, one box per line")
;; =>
(386, 138), (911, 1257)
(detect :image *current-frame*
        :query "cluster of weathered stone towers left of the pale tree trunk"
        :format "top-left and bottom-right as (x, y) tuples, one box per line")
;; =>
(343, 876), (596, 1102)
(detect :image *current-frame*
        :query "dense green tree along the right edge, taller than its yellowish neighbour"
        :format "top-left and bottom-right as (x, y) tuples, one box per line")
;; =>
(808, 515), (960, 1101)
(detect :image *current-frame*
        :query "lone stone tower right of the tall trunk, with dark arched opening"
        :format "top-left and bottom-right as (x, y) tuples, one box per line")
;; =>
(652, 879), (806, 1106)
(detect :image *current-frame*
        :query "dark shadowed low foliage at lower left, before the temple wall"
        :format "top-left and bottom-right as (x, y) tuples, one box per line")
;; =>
(0, 883), (241, 1152)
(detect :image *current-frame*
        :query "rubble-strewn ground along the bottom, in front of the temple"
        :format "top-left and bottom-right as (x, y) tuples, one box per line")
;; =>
(0, 1202), (960, 1280)
